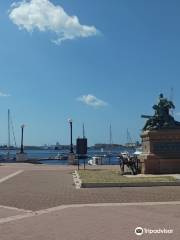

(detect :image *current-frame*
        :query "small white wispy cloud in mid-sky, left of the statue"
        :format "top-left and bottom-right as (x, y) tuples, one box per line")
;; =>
(77, 94), (108, 107)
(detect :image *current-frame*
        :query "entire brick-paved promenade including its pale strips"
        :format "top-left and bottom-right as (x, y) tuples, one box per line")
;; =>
(0, 164), (180, 240)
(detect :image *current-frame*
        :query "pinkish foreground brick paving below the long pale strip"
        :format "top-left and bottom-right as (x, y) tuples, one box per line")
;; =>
(0, 205), (180, 240)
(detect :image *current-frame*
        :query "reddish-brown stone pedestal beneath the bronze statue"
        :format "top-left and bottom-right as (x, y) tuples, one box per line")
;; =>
(139, 129), (180, 174)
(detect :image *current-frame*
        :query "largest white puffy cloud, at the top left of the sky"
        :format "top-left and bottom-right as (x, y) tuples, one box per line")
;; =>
(9, 0), (99, 44)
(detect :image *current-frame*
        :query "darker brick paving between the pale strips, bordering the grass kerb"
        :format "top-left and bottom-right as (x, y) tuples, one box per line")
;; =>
(0, 169), (180, 211)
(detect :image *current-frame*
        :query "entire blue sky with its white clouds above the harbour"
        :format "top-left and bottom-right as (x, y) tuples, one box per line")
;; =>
(0, 0), (180, 145)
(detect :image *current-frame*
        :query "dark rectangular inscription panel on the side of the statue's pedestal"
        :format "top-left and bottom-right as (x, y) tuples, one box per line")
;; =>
(153, 142), (180, 154)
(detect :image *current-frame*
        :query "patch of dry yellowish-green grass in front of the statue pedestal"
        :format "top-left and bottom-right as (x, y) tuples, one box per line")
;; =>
(78, 169), (176, 183)
